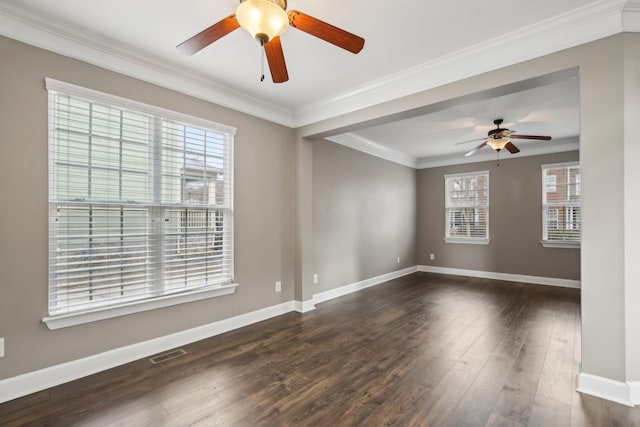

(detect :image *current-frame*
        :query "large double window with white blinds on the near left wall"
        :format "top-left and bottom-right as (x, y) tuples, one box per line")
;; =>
(44, 79), (235, 327)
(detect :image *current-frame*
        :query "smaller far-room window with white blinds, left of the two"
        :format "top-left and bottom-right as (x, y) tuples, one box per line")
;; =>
(445, 171), (489, 244)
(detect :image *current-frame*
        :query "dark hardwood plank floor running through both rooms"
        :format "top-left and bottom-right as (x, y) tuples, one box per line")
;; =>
(0, 273), (640, 427)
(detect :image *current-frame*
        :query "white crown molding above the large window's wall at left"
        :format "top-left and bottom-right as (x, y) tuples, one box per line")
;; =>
(0, 3), (295, 127)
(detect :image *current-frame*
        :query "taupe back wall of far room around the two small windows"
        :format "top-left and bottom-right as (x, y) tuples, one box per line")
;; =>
(418, 151), (580, 280)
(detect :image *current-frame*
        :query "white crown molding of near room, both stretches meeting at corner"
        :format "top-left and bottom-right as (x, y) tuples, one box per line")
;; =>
(0, 0), (640, 128)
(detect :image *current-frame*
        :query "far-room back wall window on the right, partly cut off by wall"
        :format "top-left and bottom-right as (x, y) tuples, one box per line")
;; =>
(542, 162), (582, 247)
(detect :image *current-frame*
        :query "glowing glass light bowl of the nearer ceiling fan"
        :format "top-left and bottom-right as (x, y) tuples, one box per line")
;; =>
(236, 0), (289, 44)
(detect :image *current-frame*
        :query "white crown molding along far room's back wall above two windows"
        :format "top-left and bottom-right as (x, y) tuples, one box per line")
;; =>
(416, 137), (580, 169)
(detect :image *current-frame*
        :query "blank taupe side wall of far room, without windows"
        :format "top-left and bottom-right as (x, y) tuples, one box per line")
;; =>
(312, 140), (416, 293)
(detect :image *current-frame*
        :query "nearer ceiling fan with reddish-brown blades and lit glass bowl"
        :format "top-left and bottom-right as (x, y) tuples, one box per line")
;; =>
(176, 0), (364, 83)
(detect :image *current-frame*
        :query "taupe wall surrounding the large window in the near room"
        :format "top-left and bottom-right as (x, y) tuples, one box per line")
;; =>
(0, 37), (295, 379)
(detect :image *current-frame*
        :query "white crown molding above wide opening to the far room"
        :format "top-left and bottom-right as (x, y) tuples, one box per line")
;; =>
(295, 0), (640, 126)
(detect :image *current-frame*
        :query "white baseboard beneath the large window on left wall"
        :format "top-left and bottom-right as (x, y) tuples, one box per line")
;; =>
(0, 301), (299, 403)
